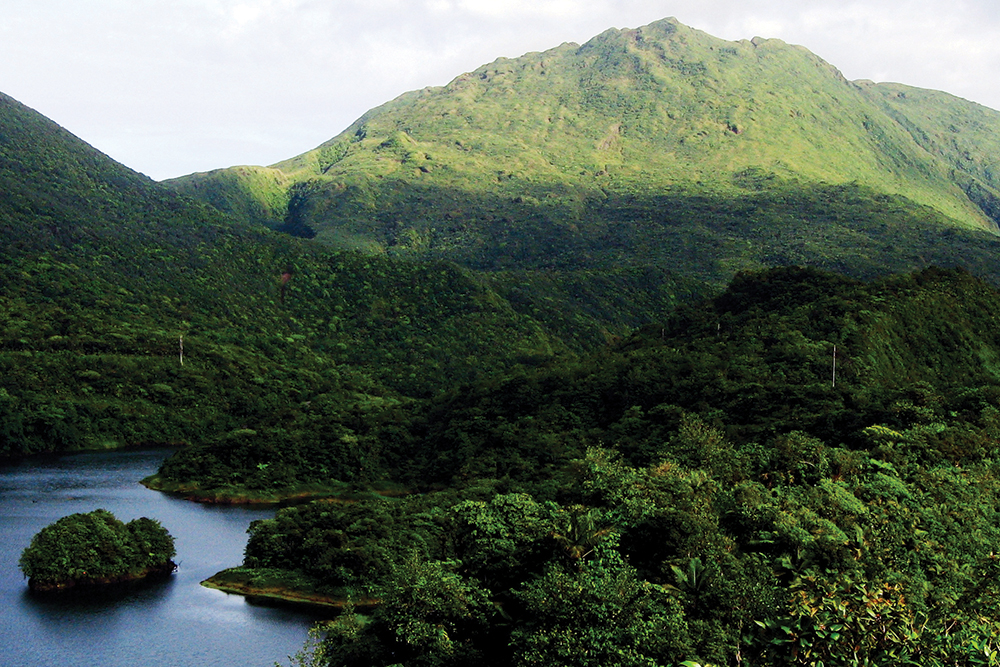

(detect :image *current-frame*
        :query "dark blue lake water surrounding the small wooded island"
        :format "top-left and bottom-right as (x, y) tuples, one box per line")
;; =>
(0, 451), (326, 667)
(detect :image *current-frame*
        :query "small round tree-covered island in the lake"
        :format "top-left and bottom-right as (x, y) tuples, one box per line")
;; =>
(18, 509), (177, 591)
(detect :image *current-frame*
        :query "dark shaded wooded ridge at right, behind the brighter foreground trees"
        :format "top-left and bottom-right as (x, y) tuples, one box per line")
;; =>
(152, 268), (1000, 490)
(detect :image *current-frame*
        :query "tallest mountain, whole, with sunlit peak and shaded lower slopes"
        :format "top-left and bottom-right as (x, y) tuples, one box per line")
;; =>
(166, 19), (1000, 286)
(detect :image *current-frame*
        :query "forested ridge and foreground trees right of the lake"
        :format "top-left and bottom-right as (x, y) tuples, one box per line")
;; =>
(186, 268), (1000, 667)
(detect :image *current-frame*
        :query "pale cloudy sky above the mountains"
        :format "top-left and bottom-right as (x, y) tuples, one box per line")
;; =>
(0, 0), (1000, 180)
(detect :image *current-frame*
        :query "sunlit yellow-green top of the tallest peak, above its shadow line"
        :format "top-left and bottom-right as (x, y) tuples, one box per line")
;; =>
(275, 19), (995, 215)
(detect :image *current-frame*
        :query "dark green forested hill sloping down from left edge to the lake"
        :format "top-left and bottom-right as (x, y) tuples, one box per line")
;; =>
(0, 96), (584, 457)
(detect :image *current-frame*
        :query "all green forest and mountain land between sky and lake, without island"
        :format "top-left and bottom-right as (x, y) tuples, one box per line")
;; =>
(0, 14), (1000, 667)
